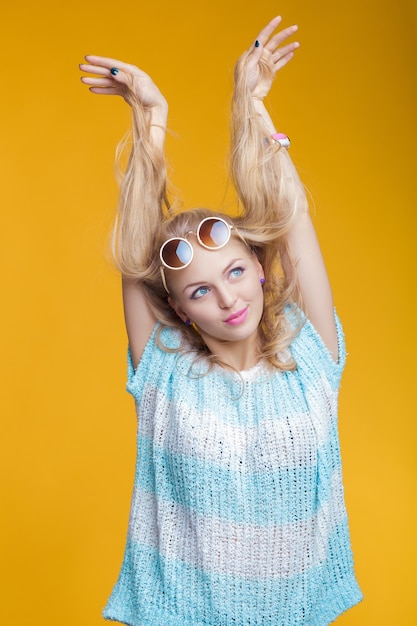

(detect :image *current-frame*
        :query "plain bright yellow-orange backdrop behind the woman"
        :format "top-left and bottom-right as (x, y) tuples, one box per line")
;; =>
(0, 0), (417, 626)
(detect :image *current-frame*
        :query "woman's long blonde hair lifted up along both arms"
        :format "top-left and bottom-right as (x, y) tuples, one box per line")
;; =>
(112, 53), (306, 370)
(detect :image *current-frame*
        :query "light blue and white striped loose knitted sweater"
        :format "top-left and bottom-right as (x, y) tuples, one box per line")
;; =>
(104, 310), (361, 626)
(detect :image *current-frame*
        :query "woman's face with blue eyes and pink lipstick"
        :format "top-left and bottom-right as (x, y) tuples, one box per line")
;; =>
(167, 236), (264, 352)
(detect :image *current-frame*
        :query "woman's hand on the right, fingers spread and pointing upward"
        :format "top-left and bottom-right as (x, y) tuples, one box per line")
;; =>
(243, 16), (300, 100)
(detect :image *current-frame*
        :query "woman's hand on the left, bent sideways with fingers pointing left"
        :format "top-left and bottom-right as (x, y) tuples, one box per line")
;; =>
(80, 55), (168, 110)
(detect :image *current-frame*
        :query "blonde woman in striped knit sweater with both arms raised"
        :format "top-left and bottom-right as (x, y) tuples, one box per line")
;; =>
(80, 17), (361, 626)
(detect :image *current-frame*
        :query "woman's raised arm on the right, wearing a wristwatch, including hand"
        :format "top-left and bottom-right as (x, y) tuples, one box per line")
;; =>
(231, 17), (338, 360)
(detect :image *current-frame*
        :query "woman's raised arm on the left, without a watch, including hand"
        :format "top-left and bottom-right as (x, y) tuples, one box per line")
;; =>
(80, 56), (168, 365)
